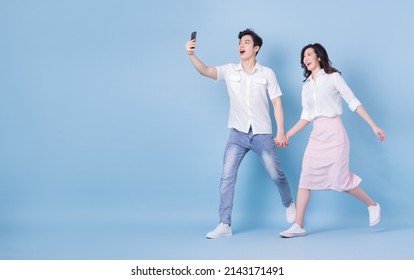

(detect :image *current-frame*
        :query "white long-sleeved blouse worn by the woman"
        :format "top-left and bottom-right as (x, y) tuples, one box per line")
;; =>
(300, 69), (361, 121)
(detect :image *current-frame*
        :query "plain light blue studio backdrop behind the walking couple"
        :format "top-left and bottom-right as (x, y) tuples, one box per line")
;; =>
(0, 0), (414, 259)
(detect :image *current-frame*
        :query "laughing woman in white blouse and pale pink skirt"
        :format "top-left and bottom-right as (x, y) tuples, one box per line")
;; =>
(280, 43), (386, 237)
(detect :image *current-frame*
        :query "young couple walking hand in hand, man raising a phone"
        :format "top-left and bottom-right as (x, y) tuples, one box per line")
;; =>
(185, 29), (385, 239)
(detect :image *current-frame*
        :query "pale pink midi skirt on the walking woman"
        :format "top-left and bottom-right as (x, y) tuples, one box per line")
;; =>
(299, 116), (362, 192)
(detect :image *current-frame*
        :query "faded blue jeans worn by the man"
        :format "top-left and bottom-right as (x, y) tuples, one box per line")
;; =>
(219, 129), (293, 224)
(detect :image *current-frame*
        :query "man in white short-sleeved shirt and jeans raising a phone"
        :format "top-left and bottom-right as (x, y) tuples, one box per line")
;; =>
(185, 29), (296, 239)
